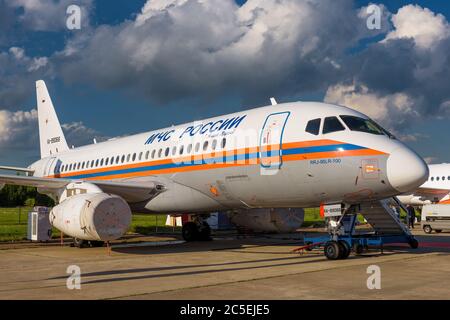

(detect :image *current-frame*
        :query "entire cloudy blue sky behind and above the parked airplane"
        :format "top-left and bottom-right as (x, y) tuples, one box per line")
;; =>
(0, 0), (450, 165)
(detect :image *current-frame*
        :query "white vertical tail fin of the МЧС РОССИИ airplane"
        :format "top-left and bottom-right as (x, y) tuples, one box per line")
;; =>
(36, 80), (69, 158)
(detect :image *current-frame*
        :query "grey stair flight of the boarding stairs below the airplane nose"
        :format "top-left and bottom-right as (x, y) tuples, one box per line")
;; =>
(358, 197), (411, 236)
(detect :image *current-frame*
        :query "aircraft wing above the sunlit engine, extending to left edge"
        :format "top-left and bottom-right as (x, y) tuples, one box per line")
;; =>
(0, 174), (165, 202)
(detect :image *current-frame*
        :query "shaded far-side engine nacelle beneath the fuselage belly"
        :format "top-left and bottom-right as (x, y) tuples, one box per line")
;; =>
(230, 208), (305, 233)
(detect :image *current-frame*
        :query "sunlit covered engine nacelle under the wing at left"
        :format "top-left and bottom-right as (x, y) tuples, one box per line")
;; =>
(50, 193), (131, 241)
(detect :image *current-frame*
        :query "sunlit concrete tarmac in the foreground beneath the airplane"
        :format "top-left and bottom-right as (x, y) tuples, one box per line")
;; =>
(0, 229), (450, 300)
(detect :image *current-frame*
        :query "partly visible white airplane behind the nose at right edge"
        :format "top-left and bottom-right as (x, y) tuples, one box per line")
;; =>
(397, 163), (450, 206)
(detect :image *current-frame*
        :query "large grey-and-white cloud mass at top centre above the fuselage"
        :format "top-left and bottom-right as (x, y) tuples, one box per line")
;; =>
(57, 0), (378, 102)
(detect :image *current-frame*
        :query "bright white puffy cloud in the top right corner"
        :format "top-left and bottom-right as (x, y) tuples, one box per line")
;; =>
(384, 4), (450, 48)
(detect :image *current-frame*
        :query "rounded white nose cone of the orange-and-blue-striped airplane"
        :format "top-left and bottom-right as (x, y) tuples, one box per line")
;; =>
(387, 147), (429, 193)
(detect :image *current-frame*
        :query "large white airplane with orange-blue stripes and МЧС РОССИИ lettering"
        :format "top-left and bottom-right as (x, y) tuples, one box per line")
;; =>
(0, 80), (428, 258)
